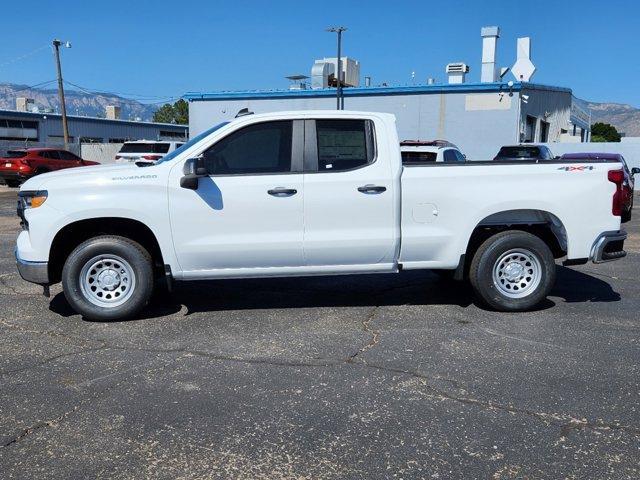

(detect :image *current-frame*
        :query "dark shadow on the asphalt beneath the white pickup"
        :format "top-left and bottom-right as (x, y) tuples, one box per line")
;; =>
(49, 266), (620, 319)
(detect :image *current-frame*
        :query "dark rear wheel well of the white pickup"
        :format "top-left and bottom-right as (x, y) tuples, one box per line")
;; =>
(465, 210), (567, 274)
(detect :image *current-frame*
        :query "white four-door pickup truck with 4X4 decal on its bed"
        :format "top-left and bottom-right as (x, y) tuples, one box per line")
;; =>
(16, 111), (626, 320)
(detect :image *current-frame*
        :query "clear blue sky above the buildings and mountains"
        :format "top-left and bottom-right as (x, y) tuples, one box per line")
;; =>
(0, 0), (640, 107)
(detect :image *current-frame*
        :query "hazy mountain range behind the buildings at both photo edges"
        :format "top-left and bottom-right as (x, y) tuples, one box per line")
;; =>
(0, 83), (640, 137)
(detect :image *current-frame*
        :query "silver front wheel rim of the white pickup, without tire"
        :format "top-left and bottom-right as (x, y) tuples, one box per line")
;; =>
(80, 254), (136, 308)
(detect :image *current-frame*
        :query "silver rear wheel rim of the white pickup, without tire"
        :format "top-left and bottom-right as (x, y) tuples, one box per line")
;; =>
(493, 248), (542, 298)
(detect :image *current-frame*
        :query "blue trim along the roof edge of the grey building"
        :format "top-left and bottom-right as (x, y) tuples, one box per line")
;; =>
(183, 82), (571, 102)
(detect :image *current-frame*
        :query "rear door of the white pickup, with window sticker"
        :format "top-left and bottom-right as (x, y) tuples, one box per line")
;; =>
(304, 119), (397, 269)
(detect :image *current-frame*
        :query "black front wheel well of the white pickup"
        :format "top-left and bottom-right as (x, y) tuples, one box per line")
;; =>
(49, 217), (164, 283)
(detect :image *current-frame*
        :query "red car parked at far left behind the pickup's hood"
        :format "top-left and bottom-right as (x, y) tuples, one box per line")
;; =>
(0, 148), (99, 187)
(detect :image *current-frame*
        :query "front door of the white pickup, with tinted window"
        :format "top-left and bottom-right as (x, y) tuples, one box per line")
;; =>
(169, 121), (304, 278)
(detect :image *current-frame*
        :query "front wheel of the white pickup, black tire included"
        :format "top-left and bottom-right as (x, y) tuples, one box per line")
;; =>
(62, 235), (154, 321)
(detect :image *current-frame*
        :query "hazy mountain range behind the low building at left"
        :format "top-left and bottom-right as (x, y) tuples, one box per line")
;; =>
(0, 83), (159, 121)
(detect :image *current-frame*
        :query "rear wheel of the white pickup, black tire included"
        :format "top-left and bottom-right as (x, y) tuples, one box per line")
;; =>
(469, 230), (556, 312)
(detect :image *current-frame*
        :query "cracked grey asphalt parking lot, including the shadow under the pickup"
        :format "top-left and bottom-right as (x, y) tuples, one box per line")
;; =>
(0, 187), (640, 479)
